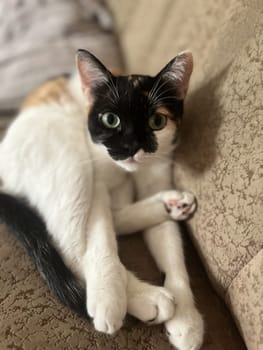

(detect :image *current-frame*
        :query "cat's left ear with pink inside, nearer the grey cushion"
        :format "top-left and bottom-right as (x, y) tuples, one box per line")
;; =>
(76, 50), (111, 96)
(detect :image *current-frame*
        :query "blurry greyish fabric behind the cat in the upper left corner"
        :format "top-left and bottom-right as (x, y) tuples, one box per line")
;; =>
(0, 0), (121, 109)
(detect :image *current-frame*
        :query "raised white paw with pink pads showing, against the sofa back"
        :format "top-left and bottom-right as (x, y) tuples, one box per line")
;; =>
(161, 191), (196, 220)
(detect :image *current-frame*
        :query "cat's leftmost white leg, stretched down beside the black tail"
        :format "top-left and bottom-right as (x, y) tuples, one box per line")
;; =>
(83, 184), (127, 334)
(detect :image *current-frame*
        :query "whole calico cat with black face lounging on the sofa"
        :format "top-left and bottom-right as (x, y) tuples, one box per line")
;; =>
(0, 50), (203, 350)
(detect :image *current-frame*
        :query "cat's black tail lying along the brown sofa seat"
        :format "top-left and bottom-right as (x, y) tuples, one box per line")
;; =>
(0, 193), (88, 318)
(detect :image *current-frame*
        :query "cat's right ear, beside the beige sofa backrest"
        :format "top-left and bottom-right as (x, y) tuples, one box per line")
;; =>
(157, 51), (193, 100)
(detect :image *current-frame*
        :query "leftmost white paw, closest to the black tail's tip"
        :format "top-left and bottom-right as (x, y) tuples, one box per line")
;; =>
(87, 263), (127, 334)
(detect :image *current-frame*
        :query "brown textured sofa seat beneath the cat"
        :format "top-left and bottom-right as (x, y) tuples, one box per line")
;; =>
(0, 216), (248, 350)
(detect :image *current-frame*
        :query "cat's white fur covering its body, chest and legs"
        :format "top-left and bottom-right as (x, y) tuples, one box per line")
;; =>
(0, 72), (203, 350)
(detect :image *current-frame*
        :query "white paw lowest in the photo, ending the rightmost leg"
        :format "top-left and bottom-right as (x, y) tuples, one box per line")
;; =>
(165, 306), (204, 350)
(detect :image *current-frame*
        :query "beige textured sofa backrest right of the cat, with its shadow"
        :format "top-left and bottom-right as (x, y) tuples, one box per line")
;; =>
(108, 0), (263, 350)
